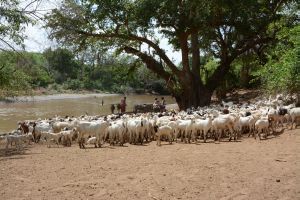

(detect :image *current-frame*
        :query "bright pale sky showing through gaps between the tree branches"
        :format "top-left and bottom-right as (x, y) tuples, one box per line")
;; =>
(24, 0), (181, 64)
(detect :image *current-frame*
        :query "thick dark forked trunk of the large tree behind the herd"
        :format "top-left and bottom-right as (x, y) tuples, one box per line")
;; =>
(124, 47), (219, 110)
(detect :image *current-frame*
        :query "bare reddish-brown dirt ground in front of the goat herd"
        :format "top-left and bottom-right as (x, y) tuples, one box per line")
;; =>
(0, 129), (300, 200)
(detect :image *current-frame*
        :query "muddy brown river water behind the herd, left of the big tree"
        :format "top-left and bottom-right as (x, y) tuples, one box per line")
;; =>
(0, 94), (175, 133)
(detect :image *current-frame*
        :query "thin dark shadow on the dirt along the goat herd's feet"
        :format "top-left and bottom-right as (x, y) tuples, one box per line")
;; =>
(0, 130), (283, 161)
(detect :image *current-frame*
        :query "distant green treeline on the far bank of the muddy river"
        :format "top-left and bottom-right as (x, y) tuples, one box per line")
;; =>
(0, 48), (168, 96)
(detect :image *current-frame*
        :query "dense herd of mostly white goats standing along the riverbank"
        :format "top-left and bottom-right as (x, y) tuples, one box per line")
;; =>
(0, 94), (300, 151)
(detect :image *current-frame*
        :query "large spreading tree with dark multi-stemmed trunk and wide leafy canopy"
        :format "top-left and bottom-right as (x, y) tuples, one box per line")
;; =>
(47, 0), (293, 109)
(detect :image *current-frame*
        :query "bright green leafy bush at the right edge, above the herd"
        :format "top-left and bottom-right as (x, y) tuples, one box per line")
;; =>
(254, 25), (300, 93)
